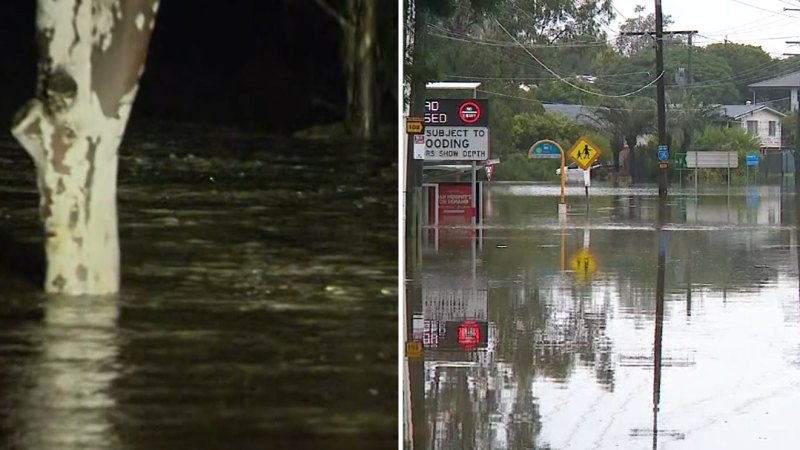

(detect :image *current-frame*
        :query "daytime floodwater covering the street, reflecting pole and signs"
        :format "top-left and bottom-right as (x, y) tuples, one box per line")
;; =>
(404, 180), (800, 450)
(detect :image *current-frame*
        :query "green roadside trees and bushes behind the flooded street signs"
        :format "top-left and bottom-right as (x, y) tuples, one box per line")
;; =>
(404, 0), (800, 182)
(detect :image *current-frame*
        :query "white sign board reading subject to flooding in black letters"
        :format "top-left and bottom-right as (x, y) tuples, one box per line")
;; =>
(421, 125), (489, 161)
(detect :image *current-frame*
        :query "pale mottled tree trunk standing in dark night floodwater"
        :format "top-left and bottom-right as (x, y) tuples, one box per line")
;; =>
(11, 0), (158, 295)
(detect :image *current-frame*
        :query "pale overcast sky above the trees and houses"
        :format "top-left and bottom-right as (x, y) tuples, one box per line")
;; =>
(605, 0), (800, 57)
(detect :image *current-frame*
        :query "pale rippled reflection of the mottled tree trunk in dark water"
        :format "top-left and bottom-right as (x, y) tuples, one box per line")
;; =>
(15, 297), (119, 448)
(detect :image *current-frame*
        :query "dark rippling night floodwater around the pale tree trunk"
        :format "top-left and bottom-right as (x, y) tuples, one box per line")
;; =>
(0, 127), (397, 449)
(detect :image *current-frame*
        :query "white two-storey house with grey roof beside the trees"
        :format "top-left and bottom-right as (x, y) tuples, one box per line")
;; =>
(719, 102), (786, 153)
